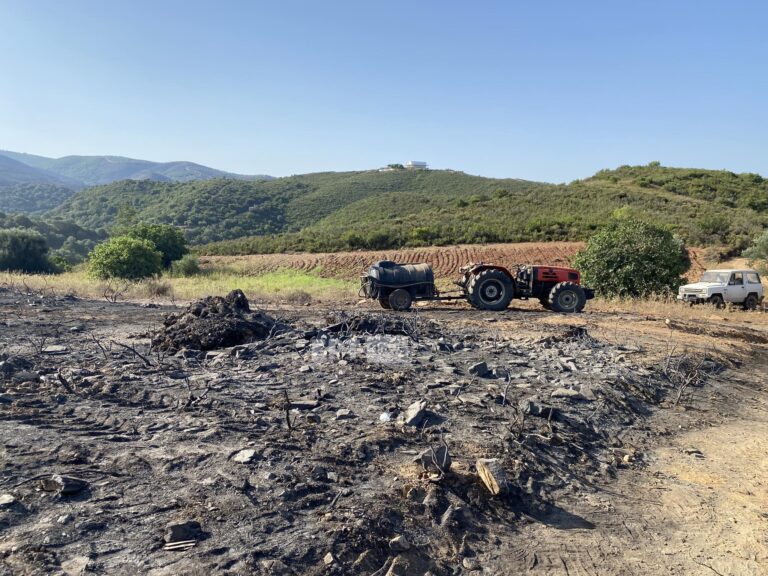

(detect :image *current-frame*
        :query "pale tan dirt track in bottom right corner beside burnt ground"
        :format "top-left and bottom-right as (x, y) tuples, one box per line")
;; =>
(499, 390), (768, 576)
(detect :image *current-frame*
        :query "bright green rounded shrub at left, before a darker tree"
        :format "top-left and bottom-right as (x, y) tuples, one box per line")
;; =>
(88, 236), (163, 280)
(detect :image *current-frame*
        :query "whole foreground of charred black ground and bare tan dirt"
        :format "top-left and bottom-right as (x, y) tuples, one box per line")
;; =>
(0, 288), (768, 576)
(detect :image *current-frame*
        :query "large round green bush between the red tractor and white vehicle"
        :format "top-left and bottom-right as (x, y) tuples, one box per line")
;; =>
(574, 219), (691, 296)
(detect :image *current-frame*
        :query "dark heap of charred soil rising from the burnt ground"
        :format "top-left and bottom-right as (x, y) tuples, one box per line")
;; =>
(152, 290), (279, 354)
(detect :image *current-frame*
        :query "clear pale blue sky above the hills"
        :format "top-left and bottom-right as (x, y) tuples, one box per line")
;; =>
(0, 0), (768, 182)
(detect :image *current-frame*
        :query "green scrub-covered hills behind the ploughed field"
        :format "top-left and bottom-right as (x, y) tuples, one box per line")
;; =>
(46, 163), (768, 254)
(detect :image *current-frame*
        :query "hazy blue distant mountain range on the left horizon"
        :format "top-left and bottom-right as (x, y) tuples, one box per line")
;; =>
(0, 150), (272, 213)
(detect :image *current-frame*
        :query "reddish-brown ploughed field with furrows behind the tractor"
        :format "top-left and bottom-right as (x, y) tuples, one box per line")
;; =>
(201, 242), (705, 279)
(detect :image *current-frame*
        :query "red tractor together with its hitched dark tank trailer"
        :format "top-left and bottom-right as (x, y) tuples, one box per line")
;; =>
(360, 260), (595, 312)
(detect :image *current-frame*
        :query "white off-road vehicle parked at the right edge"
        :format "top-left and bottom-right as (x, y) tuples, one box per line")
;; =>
(677, 270), (763, 310)
